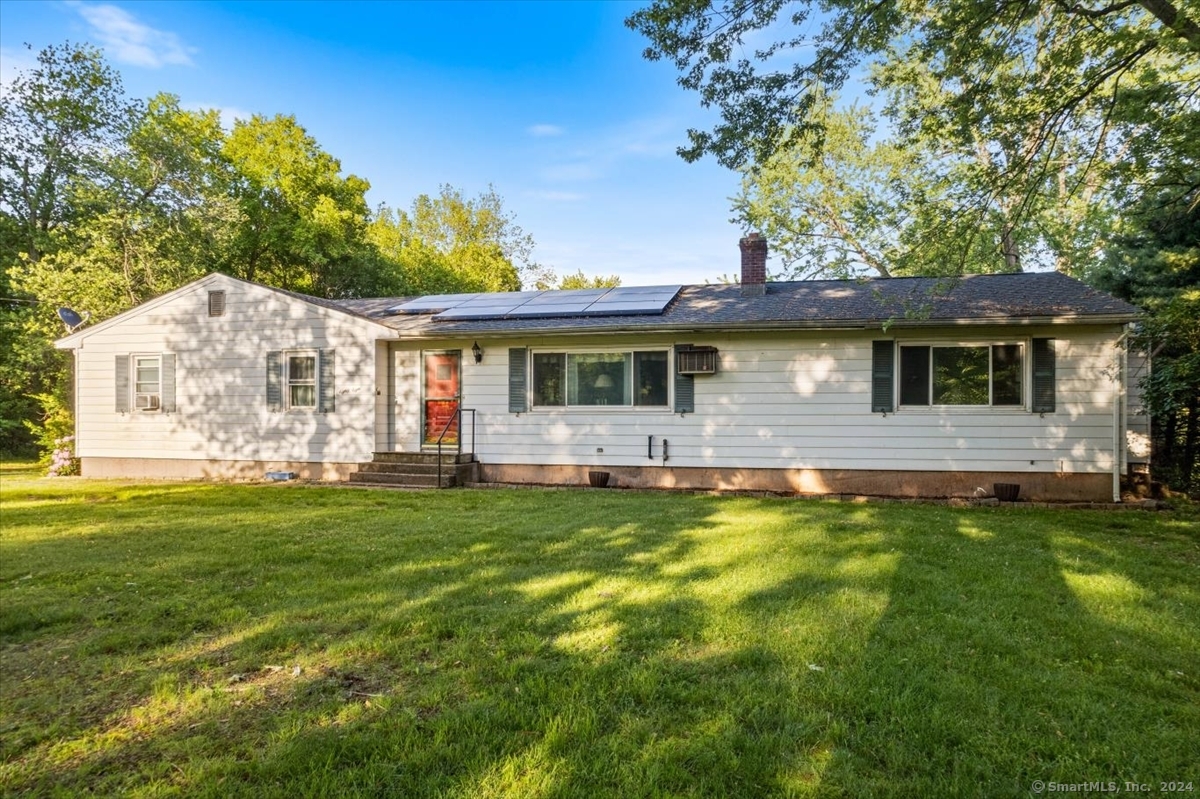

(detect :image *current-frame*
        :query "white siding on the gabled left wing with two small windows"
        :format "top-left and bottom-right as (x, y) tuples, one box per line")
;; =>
(76, 273), (386, 463)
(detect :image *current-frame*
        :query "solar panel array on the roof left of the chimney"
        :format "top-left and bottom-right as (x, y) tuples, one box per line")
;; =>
(388, 286), (683, 322)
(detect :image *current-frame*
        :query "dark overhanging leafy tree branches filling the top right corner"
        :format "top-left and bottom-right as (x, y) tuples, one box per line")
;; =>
(626, 0), (1200, 270)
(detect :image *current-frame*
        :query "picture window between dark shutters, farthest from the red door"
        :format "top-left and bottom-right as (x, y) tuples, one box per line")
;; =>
(900, 344), (1025, 407)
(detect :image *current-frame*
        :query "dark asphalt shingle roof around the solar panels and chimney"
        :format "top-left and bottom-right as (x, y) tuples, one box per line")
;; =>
(322, 272), (1138, 336)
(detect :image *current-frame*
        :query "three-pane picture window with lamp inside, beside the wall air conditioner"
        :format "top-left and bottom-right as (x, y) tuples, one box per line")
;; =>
(533, 350), (670, 408)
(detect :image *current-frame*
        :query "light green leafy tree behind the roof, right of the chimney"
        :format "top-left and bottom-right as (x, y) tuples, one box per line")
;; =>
(733, 77), (1112, 280)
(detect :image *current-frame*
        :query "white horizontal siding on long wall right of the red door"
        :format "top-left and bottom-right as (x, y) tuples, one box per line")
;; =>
(410, 328), (1120, 473)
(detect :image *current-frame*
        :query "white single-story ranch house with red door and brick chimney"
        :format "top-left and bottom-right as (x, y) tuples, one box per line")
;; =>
(58, 235), (1148, 500)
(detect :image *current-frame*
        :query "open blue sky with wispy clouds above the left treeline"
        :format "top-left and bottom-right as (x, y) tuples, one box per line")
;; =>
(0, 0), (740, 286)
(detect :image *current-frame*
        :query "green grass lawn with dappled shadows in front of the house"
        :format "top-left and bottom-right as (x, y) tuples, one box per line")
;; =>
(0, 469), (1200, 798)
